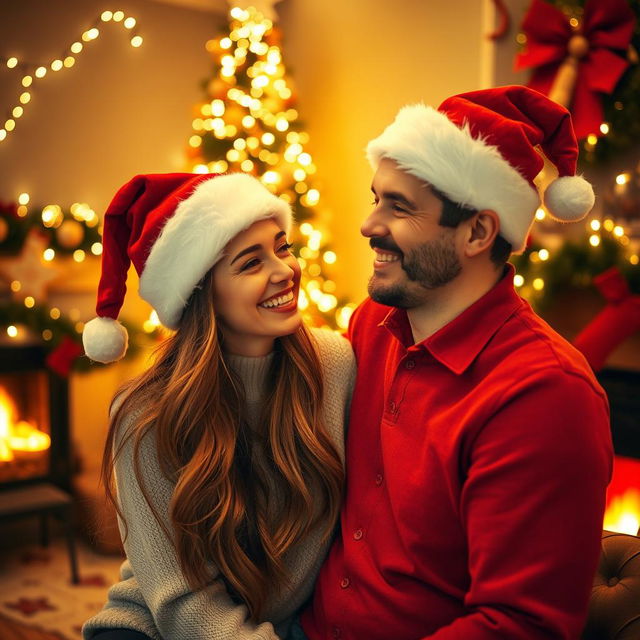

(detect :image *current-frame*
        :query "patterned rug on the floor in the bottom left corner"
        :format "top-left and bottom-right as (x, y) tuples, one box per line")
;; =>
(0, 540), (122, 640)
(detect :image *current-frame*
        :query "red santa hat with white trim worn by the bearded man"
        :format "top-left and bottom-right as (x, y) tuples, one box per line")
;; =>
(367, 86), (594, 253)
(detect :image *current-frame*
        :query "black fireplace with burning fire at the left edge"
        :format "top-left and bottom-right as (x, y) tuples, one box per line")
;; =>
(0, 345), (71, 490)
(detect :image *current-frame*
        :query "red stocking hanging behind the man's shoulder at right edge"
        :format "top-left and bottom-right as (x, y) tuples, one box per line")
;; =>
(573, 267), (640, 371)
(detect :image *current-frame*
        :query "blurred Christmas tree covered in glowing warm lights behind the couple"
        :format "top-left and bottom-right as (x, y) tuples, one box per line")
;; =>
(188, 7), (353, 329)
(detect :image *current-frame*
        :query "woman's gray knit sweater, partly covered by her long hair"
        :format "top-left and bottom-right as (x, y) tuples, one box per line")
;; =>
(82, 330), (355, 640)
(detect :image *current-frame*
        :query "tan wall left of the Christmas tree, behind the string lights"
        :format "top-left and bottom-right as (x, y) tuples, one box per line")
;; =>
(0, 0), (224, 210)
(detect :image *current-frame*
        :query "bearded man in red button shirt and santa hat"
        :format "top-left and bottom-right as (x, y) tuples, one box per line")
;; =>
(302, 87), (612, 640)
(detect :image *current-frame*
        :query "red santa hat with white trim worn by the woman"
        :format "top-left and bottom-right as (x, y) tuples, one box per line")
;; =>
(82, 173), (291, 363)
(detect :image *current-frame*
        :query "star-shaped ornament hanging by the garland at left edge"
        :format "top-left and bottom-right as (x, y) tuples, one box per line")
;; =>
(0, 231), (60, 301)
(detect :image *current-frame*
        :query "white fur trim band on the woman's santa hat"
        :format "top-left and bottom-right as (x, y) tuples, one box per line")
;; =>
(140, 173), (291, 329)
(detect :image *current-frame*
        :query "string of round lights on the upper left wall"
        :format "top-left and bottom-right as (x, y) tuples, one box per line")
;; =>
(0, 11), (143, 142)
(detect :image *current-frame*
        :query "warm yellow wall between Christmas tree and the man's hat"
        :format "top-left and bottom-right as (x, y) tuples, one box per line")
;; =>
(277, 0), (493, 301)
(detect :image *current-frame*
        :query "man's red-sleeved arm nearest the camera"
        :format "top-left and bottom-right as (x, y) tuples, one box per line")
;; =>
(425, 370), (612, 640)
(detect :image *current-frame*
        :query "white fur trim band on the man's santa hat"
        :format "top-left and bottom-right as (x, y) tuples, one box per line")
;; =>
(367, 104), (540, 253)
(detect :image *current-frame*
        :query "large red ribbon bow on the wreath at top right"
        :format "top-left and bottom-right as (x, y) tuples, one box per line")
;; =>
(515, 0), (635, 139)
